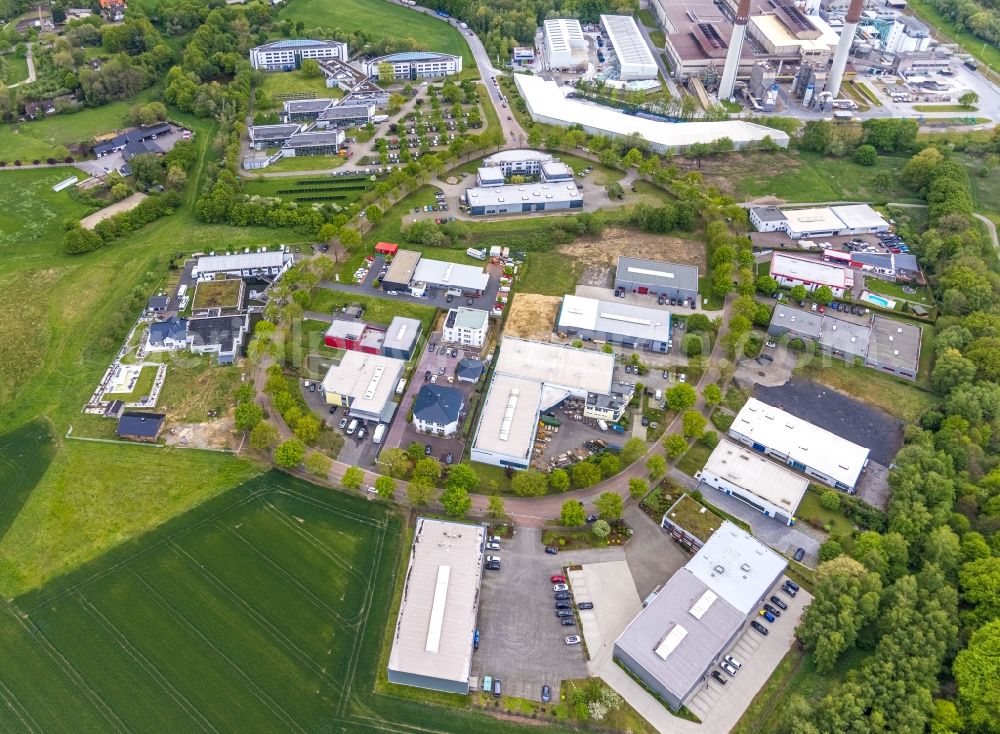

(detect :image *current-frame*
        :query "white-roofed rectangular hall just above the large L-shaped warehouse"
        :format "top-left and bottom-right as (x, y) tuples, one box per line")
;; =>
(556, 295), (670, 353)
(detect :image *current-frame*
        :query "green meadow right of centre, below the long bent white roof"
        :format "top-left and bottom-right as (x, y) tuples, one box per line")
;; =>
(733, 152), (918, 202)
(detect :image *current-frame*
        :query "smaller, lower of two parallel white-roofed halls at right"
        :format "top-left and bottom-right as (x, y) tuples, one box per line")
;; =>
(702, 439), (809, 515)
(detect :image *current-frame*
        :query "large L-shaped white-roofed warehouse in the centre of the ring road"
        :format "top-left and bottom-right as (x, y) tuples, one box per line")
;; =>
(471, 337), (635, 469)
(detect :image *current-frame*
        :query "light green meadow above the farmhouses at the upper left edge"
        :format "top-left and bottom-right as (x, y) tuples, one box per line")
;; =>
(0, 87), (159, 165)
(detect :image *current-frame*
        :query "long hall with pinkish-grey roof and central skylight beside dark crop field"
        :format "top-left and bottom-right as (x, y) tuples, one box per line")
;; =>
(388, 517), (486, 694)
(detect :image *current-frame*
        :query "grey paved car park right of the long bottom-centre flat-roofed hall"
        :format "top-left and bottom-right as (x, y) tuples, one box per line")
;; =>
(472, 528), (588, 701)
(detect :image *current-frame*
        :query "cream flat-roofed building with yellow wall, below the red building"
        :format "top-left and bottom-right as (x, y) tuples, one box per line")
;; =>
(322, 351), (406, 421)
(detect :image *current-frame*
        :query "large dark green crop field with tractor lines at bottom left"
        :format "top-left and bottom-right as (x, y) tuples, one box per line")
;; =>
(0, 472), (568, 734)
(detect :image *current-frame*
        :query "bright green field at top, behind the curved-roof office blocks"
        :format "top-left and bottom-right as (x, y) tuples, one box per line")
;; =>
(280, 0), (475, 69)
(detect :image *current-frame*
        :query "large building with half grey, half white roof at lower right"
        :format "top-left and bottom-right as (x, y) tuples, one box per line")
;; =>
(614, 521), (787, 710)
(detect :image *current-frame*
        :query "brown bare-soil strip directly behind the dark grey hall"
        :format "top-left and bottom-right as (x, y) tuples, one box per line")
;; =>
(559, 227), (705, 270)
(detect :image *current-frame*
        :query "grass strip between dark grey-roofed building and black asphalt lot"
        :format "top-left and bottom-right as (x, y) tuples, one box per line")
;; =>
(795, 359), (938, 423)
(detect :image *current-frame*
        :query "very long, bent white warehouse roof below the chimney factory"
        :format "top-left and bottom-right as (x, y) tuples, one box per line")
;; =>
(514, 74), (788, 152)
